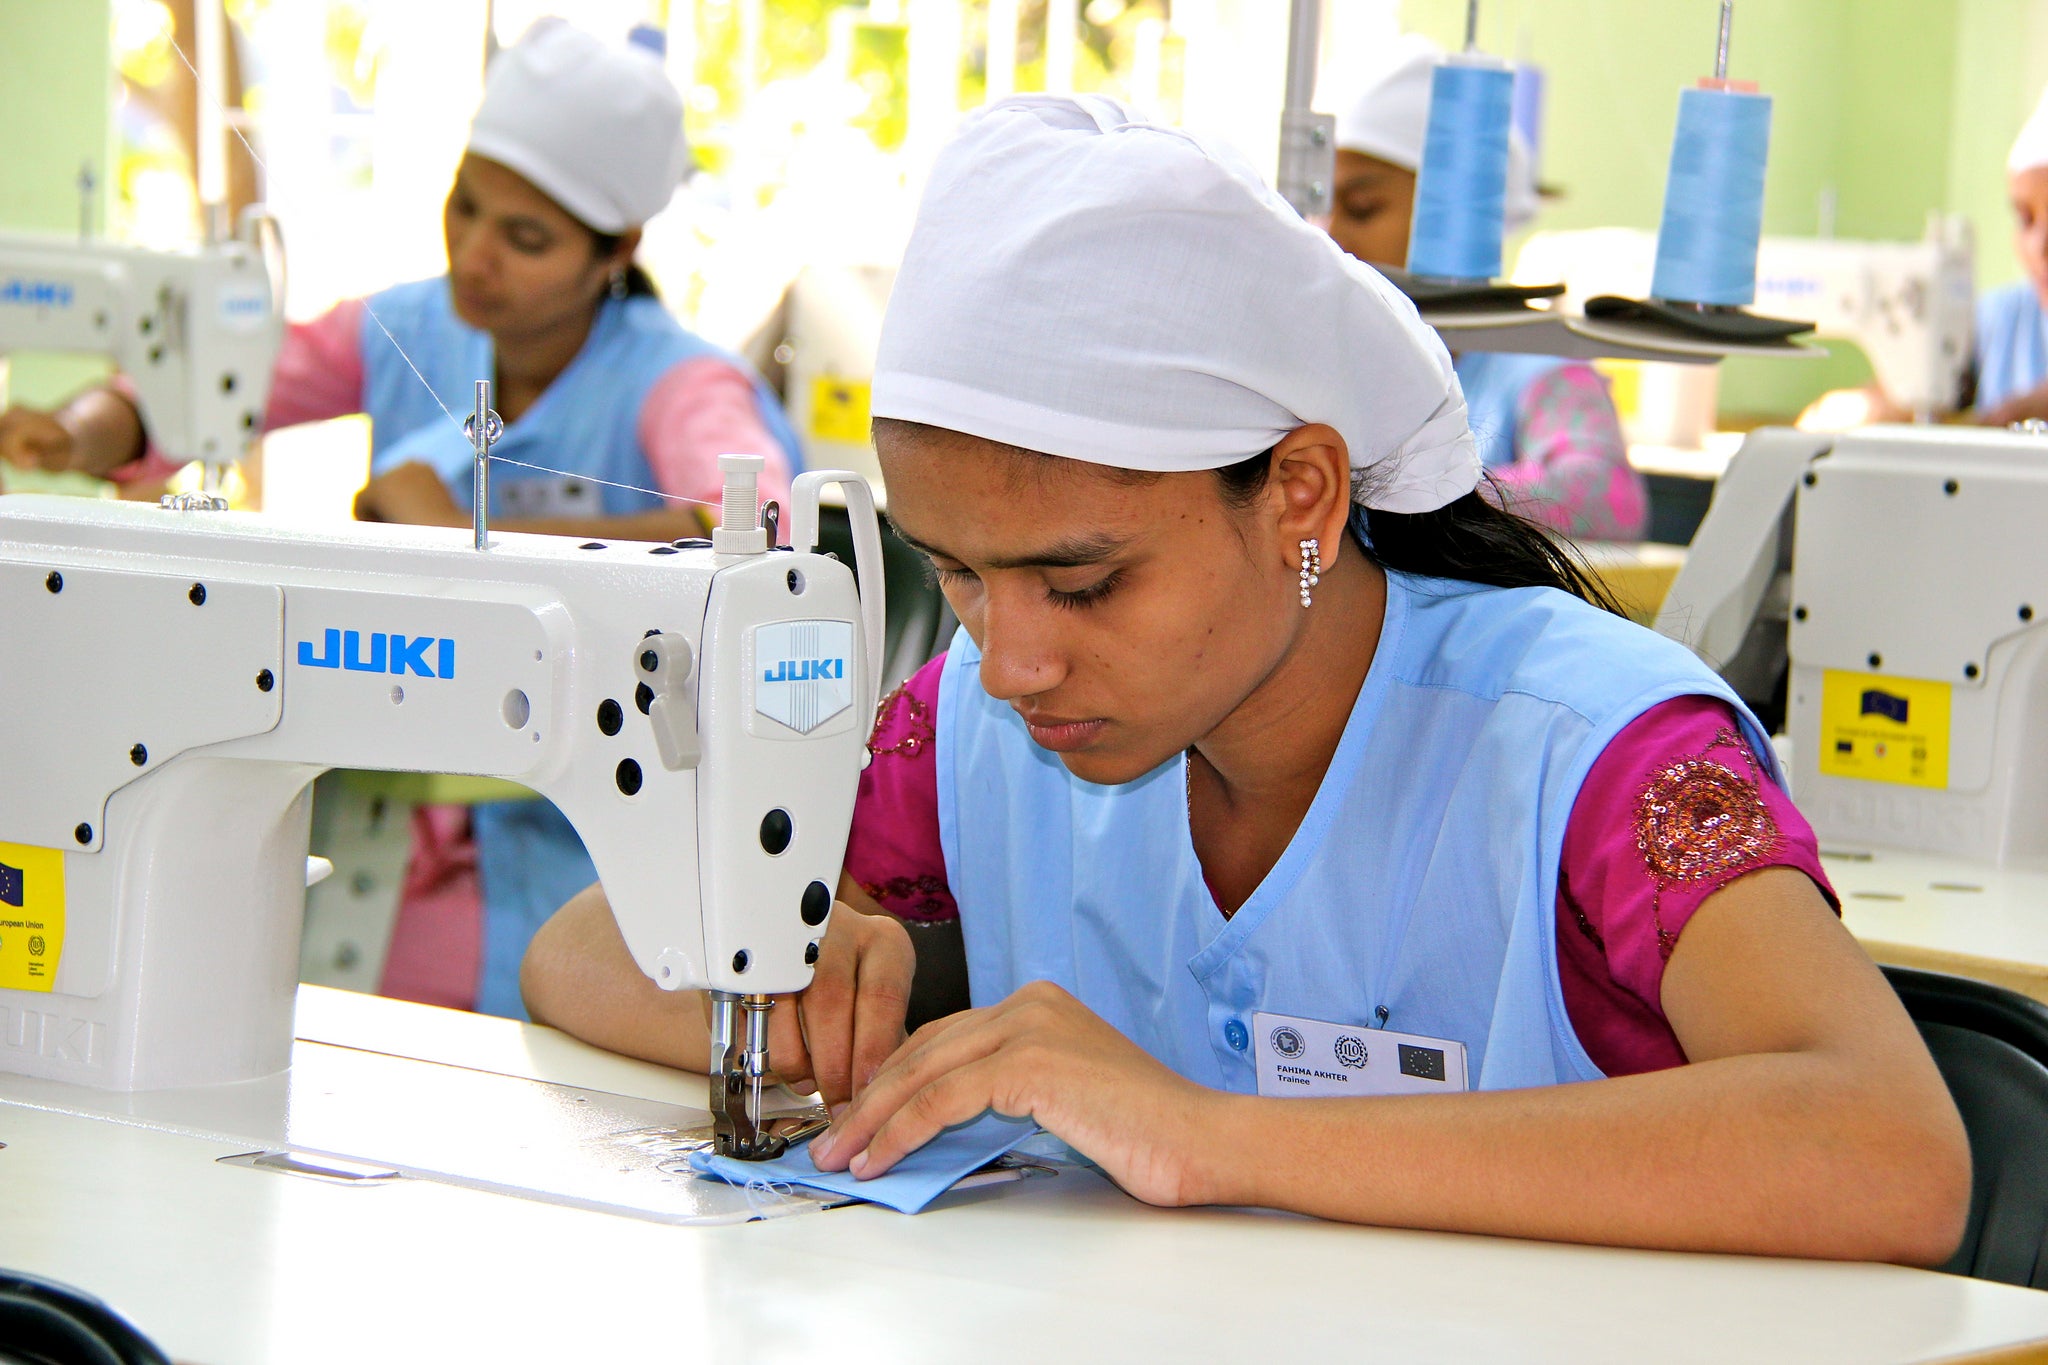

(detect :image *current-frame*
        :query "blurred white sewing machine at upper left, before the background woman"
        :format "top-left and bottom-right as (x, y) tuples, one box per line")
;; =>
(0, 209), (285, 469)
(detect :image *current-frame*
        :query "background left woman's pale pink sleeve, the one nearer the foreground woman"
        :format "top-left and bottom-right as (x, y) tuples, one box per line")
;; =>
(639, 356), (791, 520)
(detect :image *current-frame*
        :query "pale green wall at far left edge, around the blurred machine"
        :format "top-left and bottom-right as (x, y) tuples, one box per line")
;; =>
(0, 0), (115, 403)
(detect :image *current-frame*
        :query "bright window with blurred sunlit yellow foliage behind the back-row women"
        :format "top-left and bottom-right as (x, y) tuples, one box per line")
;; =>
(106, 0), (1182, 340)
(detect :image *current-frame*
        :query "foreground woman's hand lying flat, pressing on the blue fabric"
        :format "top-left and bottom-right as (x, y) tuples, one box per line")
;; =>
(811, 980), (1227, 1205)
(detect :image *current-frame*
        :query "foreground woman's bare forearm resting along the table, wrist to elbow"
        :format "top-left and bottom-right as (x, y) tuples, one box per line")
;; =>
(1196, 1052), (1970, 1265)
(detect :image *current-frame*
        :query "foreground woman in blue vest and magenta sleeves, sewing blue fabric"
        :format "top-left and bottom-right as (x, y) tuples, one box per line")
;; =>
(524, 96), (1970, 1263)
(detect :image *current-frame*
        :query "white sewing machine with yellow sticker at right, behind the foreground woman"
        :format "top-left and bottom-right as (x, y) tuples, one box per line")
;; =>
(1659, 426), (2048, 868)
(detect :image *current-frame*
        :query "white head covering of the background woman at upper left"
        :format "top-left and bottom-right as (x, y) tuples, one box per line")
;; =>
(469, 18), (690, 233)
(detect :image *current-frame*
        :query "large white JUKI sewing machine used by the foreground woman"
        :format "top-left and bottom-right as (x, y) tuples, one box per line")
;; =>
(0, 456), (883, 1156)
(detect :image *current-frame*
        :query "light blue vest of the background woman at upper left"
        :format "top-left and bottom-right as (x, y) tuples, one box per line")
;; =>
(362, 278), (803, 1019)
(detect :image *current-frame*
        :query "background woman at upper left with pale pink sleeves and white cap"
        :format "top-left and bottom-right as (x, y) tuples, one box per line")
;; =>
(0, 20), (799, 1015)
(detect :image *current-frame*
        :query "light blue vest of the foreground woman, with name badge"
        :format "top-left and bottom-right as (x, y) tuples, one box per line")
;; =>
(936, 573), (1778, 1093)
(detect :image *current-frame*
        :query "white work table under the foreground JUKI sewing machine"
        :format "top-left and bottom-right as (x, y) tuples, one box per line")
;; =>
(0, 986), (2048, 1365)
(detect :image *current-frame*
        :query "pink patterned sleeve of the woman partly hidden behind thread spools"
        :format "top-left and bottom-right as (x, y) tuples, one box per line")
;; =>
(1491, 364), (1651, 540)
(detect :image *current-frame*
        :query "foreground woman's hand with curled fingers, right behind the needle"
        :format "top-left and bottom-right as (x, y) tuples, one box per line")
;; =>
(768, 900), (918, 1113)
